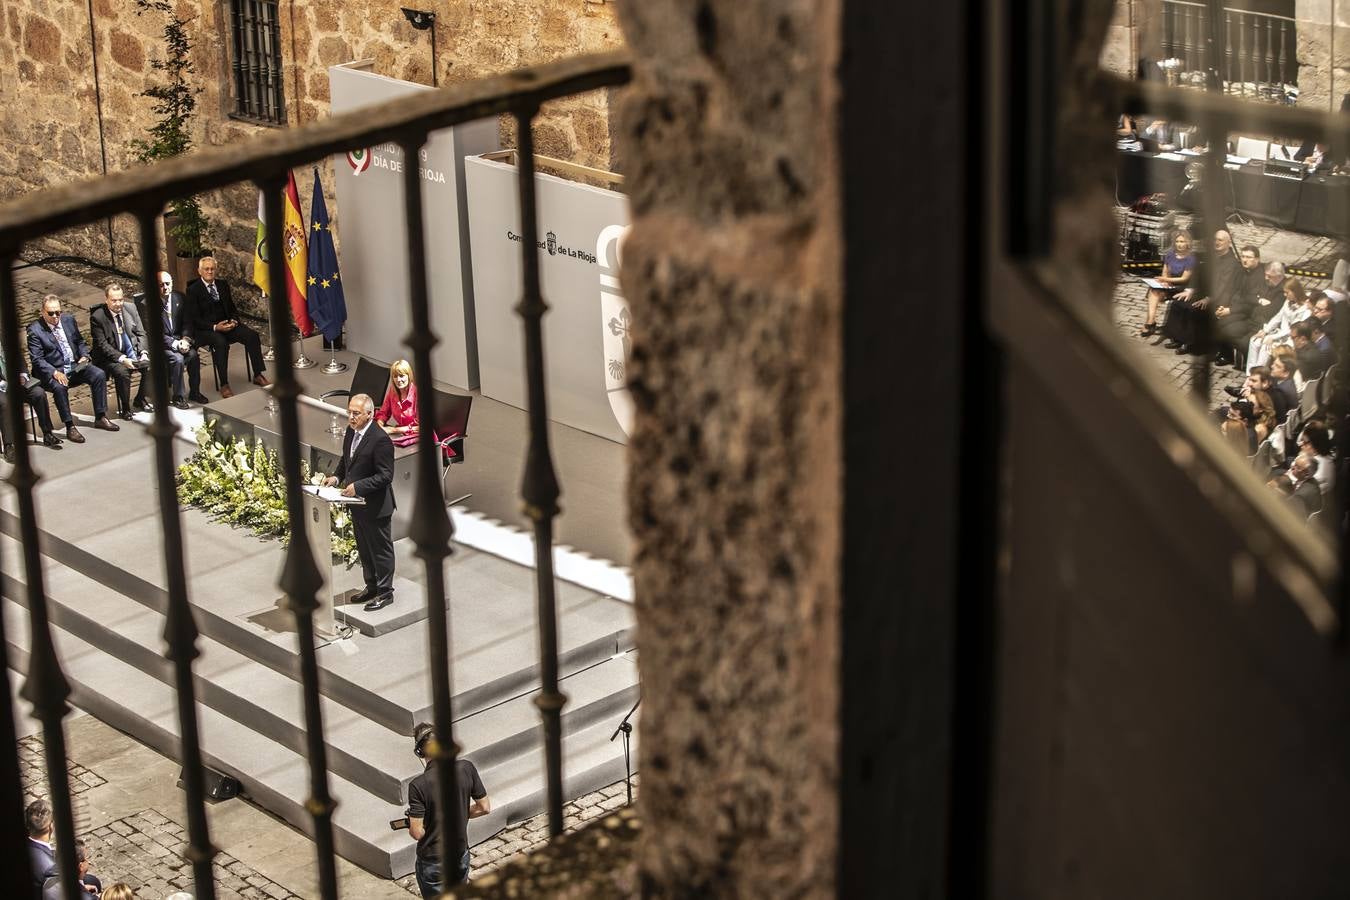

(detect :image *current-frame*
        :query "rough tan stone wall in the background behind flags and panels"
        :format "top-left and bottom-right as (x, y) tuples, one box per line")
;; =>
(0, 0), (622, 312)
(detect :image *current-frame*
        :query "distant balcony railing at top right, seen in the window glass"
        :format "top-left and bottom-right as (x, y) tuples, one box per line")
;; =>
(1162, 0), (1299, 103)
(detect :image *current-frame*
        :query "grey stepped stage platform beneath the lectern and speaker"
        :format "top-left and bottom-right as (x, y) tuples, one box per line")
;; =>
(0, 355), (637, 877)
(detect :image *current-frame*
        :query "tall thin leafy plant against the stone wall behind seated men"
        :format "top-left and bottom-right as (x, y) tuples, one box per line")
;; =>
(131, 0), (209, 285)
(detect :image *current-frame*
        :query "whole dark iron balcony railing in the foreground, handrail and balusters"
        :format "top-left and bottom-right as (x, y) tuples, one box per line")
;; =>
(0, 51), (630, 900)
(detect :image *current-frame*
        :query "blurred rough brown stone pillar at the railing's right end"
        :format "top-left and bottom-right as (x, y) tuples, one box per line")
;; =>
(616, 0), (841, 897)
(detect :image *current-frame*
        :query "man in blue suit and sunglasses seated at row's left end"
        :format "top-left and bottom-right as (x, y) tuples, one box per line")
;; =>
(28, 294), (120, 444)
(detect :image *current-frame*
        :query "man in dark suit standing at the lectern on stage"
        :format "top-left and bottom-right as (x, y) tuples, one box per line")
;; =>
(324, 394), (394, 613)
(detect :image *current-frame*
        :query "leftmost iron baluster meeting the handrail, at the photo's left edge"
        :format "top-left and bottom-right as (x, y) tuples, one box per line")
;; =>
(0, 247), (84, 900)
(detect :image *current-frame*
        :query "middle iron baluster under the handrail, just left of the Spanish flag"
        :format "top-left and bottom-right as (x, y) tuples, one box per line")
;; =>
(257, 173), (338, 900)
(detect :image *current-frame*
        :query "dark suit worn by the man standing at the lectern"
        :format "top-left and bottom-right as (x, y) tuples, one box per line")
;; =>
(333, 420), (394, 596)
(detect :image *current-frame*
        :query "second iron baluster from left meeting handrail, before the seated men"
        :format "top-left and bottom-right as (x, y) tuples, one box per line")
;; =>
(139, 206), (216, 900)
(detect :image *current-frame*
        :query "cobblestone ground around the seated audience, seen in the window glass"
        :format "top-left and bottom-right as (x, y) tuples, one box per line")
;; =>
(1111, 212), (1341, 409)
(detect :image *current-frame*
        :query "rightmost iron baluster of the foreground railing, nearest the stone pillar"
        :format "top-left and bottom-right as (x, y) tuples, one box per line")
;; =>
(516, 107), (567, 835)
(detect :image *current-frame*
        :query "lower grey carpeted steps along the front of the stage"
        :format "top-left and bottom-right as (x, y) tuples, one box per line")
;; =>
(4, 591), (636, 877)
